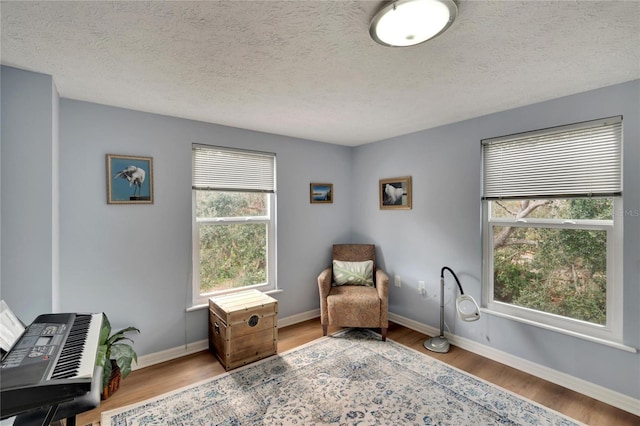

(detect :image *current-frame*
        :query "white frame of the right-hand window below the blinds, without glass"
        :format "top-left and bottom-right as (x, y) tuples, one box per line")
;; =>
(482, 197), (623, 343)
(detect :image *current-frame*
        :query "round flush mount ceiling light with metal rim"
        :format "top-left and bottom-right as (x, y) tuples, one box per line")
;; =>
(369, 0), (458, 47)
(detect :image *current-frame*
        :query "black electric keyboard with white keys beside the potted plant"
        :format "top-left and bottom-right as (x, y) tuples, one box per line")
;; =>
(0, 313), (103, 419)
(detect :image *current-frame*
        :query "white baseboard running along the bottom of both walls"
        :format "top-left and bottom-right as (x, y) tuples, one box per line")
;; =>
(132, 309), (640, 416)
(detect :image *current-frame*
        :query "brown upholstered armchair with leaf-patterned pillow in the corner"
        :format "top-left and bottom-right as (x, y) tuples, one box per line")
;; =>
(318, 244), (389, 341)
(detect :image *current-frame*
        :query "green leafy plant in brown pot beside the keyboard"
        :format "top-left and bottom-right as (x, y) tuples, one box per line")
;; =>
(96, 314), (140, 399)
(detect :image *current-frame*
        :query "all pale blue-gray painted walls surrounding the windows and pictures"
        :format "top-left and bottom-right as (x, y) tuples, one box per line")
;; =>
(0, 67), (640, 398)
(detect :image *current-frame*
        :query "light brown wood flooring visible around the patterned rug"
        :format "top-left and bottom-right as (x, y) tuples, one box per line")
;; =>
(77, 319), (640, 426)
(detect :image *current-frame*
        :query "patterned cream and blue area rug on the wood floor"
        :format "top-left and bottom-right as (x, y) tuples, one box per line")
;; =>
(101, 329), (581, 426)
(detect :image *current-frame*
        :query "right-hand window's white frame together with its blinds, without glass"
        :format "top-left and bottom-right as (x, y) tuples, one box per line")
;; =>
(481, 115), (627, 349)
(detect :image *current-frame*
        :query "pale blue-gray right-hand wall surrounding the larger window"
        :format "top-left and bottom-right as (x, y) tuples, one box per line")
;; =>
(351, 81), (640, 398)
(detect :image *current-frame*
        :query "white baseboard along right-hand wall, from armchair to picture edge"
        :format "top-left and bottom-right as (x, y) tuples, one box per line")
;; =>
(389, 312), (640, 416)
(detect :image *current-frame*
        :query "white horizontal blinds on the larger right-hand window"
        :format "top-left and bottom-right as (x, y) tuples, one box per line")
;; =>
(482, 116), (622, 200)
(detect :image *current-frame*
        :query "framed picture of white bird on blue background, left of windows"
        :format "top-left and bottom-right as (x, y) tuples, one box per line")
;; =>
(107, 154), (153, 204)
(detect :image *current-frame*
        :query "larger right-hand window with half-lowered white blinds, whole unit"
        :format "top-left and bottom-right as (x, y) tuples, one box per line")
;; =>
(482, 117), (622, 343)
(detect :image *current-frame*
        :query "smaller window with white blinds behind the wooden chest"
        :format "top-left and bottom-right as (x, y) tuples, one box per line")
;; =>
(192, 145), (276, 305)
